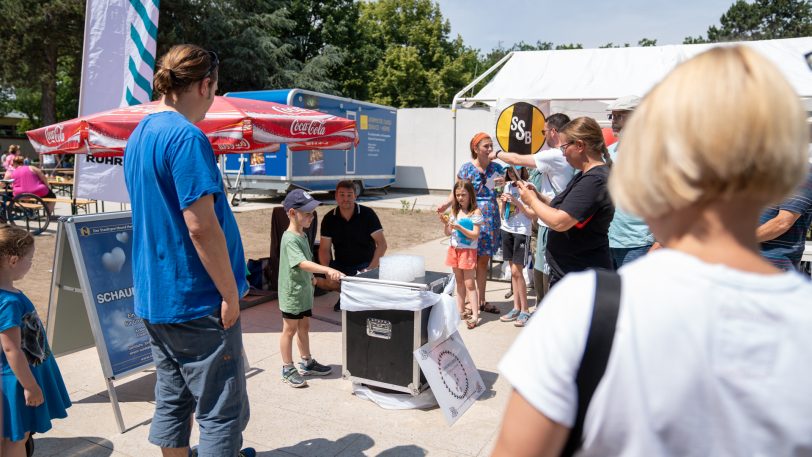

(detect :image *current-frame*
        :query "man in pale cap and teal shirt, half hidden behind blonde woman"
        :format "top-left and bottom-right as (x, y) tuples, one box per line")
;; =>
(607, 95), (655, 270)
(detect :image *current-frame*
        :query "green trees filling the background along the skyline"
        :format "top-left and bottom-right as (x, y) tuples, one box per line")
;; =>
(0, 0), (812, 128)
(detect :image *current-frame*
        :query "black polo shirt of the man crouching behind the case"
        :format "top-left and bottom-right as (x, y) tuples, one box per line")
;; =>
(321, 203), (383, 266)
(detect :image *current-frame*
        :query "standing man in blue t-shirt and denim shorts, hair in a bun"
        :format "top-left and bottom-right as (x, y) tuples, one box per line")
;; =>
(124, 45), (255, 457)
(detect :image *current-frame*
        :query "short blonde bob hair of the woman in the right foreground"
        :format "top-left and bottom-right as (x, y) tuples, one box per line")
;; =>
(609, 46), (809, 218)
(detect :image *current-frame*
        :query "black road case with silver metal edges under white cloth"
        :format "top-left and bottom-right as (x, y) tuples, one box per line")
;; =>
(341, 270), (449, 395)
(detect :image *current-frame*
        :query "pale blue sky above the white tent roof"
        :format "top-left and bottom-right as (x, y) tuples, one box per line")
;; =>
(439, 0), (734, 53)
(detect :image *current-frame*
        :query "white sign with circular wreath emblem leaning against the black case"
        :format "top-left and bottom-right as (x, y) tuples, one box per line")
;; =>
(414, 332), (485, 425)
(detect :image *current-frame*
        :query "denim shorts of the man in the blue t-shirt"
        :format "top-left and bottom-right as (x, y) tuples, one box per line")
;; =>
(144, 308), (249, 457)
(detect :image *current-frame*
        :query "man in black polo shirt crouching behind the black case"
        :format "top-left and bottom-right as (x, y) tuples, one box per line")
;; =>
(319, 181), (386, 311)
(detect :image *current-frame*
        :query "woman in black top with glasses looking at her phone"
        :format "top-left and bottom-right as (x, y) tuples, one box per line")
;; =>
(519, 117), (615, 287)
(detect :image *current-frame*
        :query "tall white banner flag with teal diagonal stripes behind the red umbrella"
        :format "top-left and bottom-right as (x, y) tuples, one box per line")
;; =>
(74, 0), (158, 202)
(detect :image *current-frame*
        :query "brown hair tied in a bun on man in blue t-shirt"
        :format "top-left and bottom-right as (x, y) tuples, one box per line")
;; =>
(152, 44), (219, 94)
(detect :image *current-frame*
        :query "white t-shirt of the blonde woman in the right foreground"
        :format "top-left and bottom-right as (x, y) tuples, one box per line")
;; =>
(499, 249), (812, 456)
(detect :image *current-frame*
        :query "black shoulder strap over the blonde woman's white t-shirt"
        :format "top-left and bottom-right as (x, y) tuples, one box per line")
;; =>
(561, 270), (620, 457)
